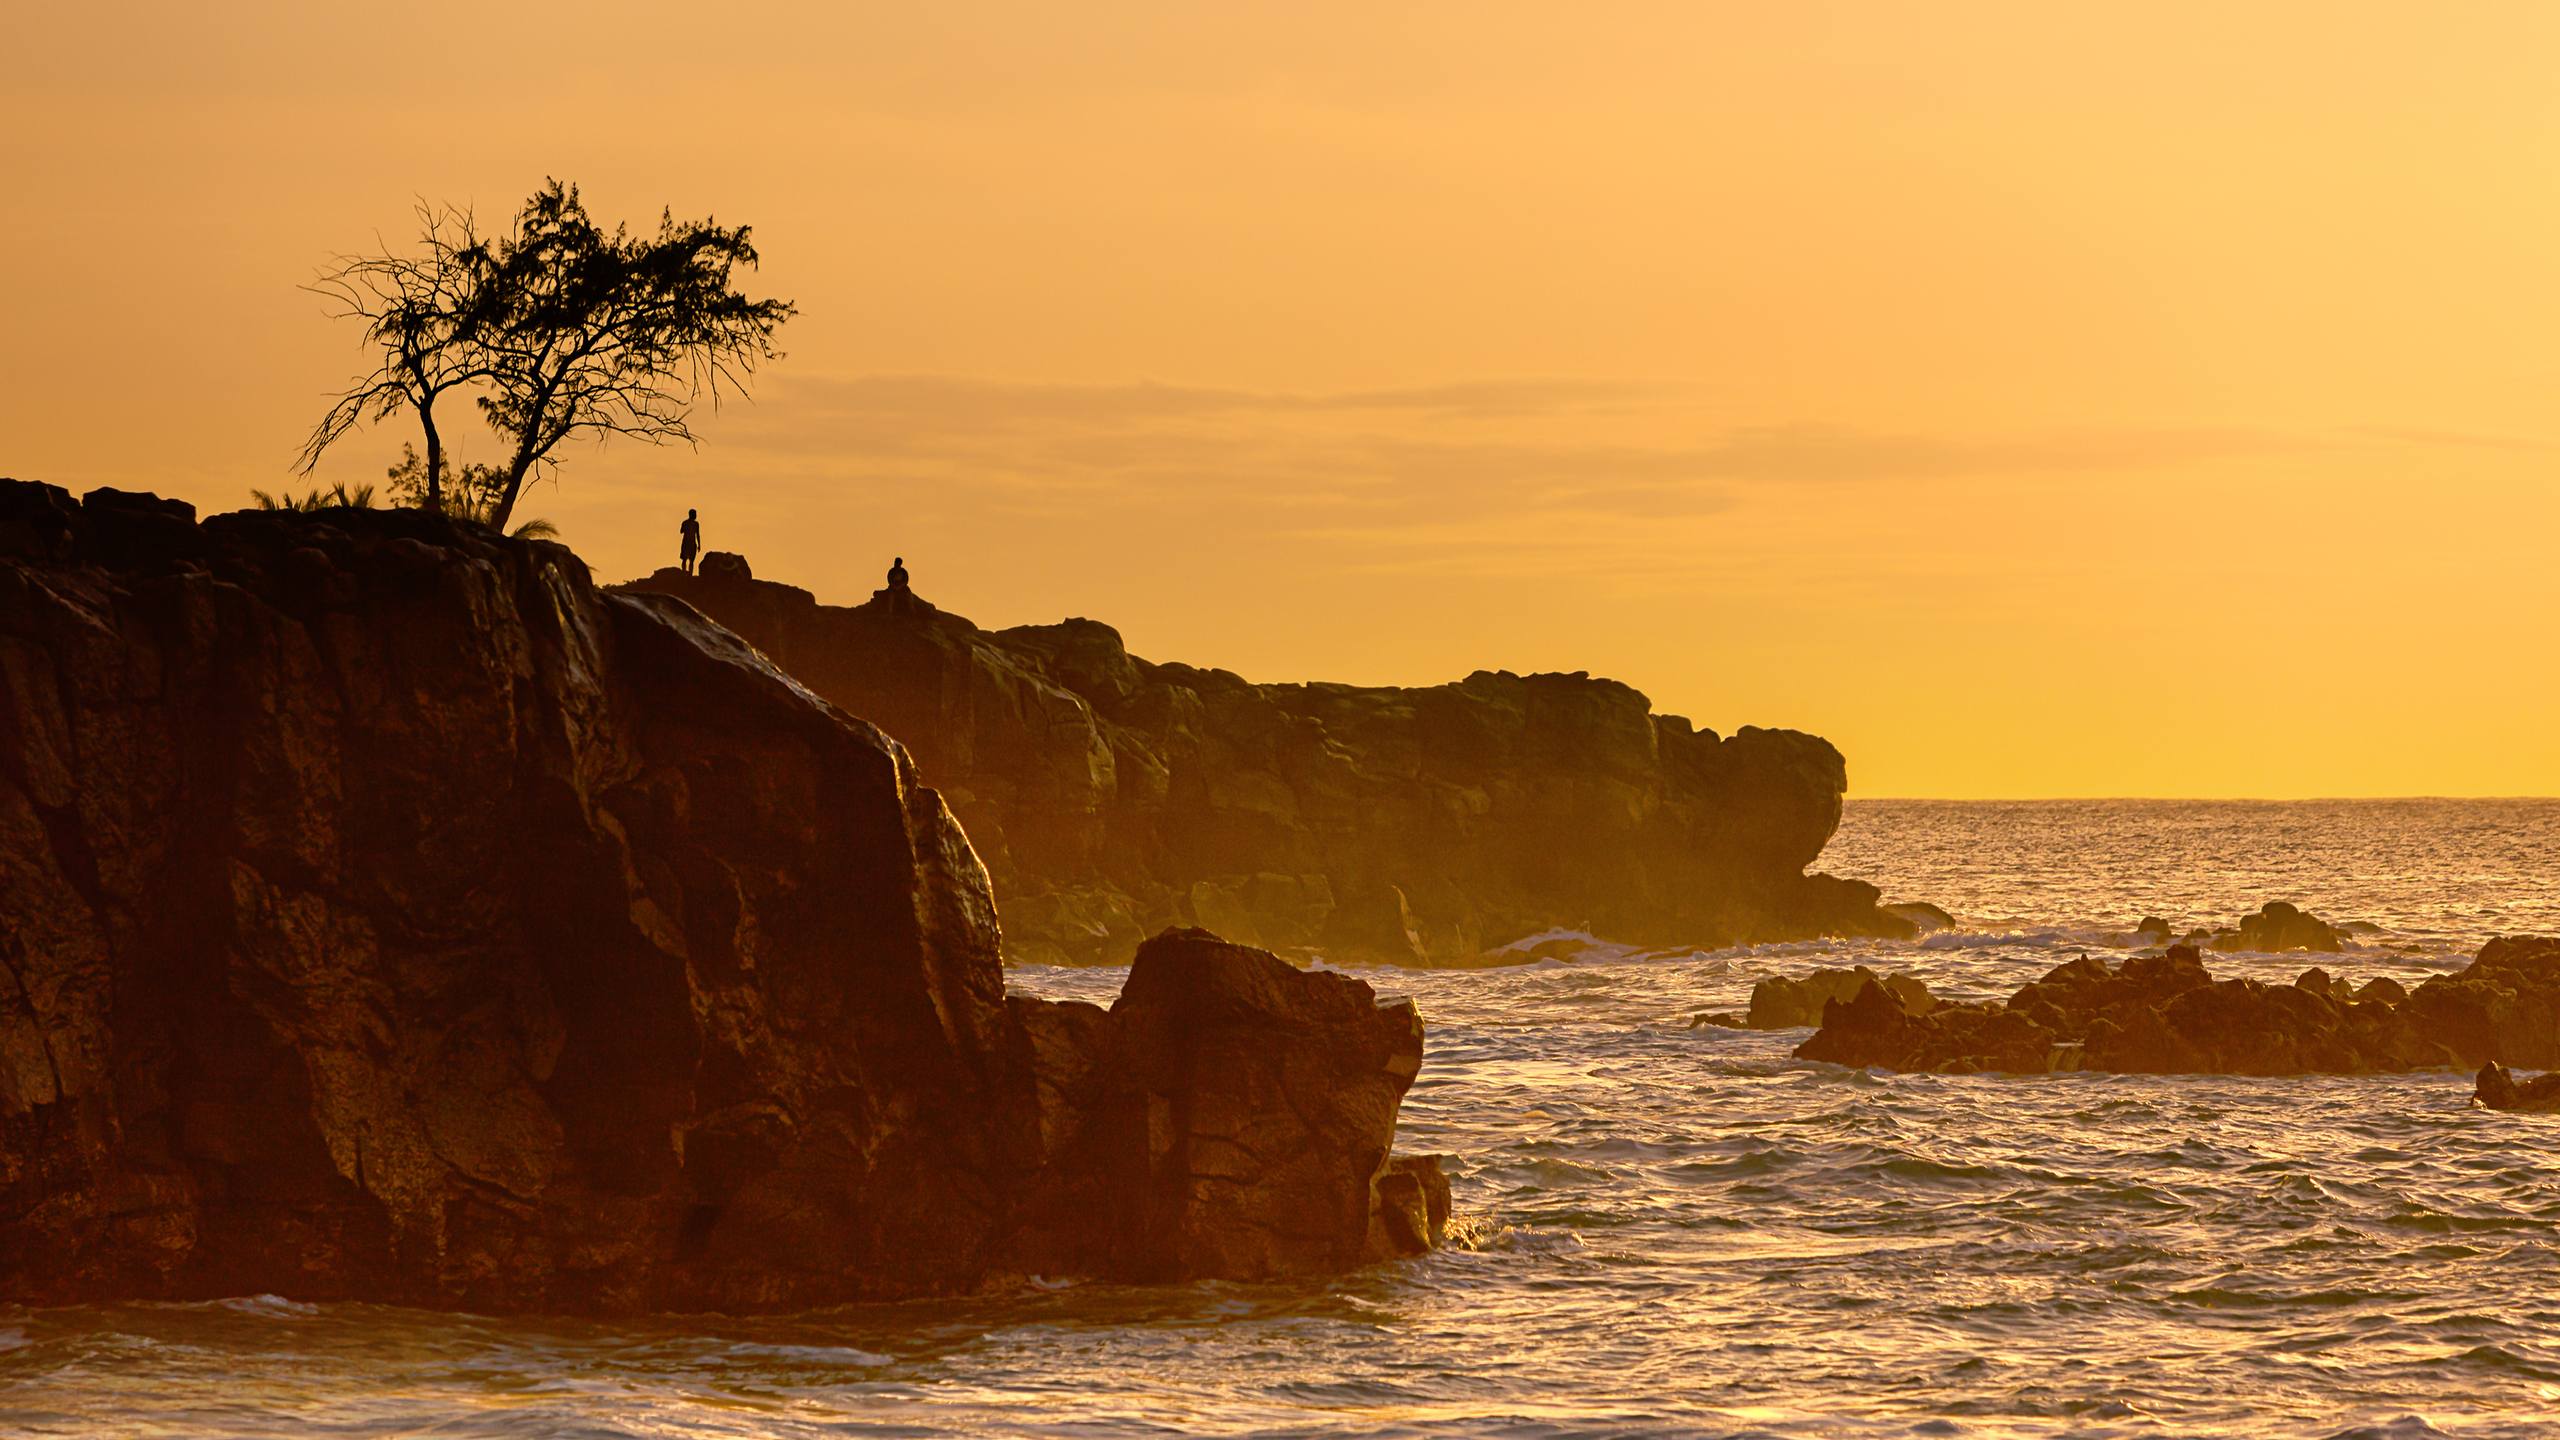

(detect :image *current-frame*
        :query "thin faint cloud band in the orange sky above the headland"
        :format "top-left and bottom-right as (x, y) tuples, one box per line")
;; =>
(691, 374), (2481, 571)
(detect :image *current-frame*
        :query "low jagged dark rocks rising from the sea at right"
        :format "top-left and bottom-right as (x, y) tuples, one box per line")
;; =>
(1795, 938), (2560, 1084)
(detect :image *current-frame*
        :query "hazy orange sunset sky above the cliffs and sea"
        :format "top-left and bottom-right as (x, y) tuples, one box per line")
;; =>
(0, 0), (2560, 794)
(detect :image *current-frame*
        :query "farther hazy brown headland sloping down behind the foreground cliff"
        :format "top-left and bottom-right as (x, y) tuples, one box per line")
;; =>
(627, 561), (1912, 963)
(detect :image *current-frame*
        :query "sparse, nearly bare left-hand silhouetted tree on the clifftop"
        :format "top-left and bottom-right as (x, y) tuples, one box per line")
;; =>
(294, 202), (499, 510)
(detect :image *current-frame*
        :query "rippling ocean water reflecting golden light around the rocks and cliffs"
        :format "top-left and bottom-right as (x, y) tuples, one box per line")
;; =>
(0, 799), (2560, 1437)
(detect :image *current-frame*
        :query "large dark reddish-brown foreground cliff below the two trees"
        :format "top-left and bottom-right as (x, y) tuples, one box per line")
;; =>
(0, 482), (1446, 1312)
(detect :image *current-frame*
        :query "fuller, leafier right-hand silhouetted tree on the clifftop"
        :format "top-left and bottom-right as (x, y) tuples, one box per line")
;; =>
(479, 179), (796, 528)
